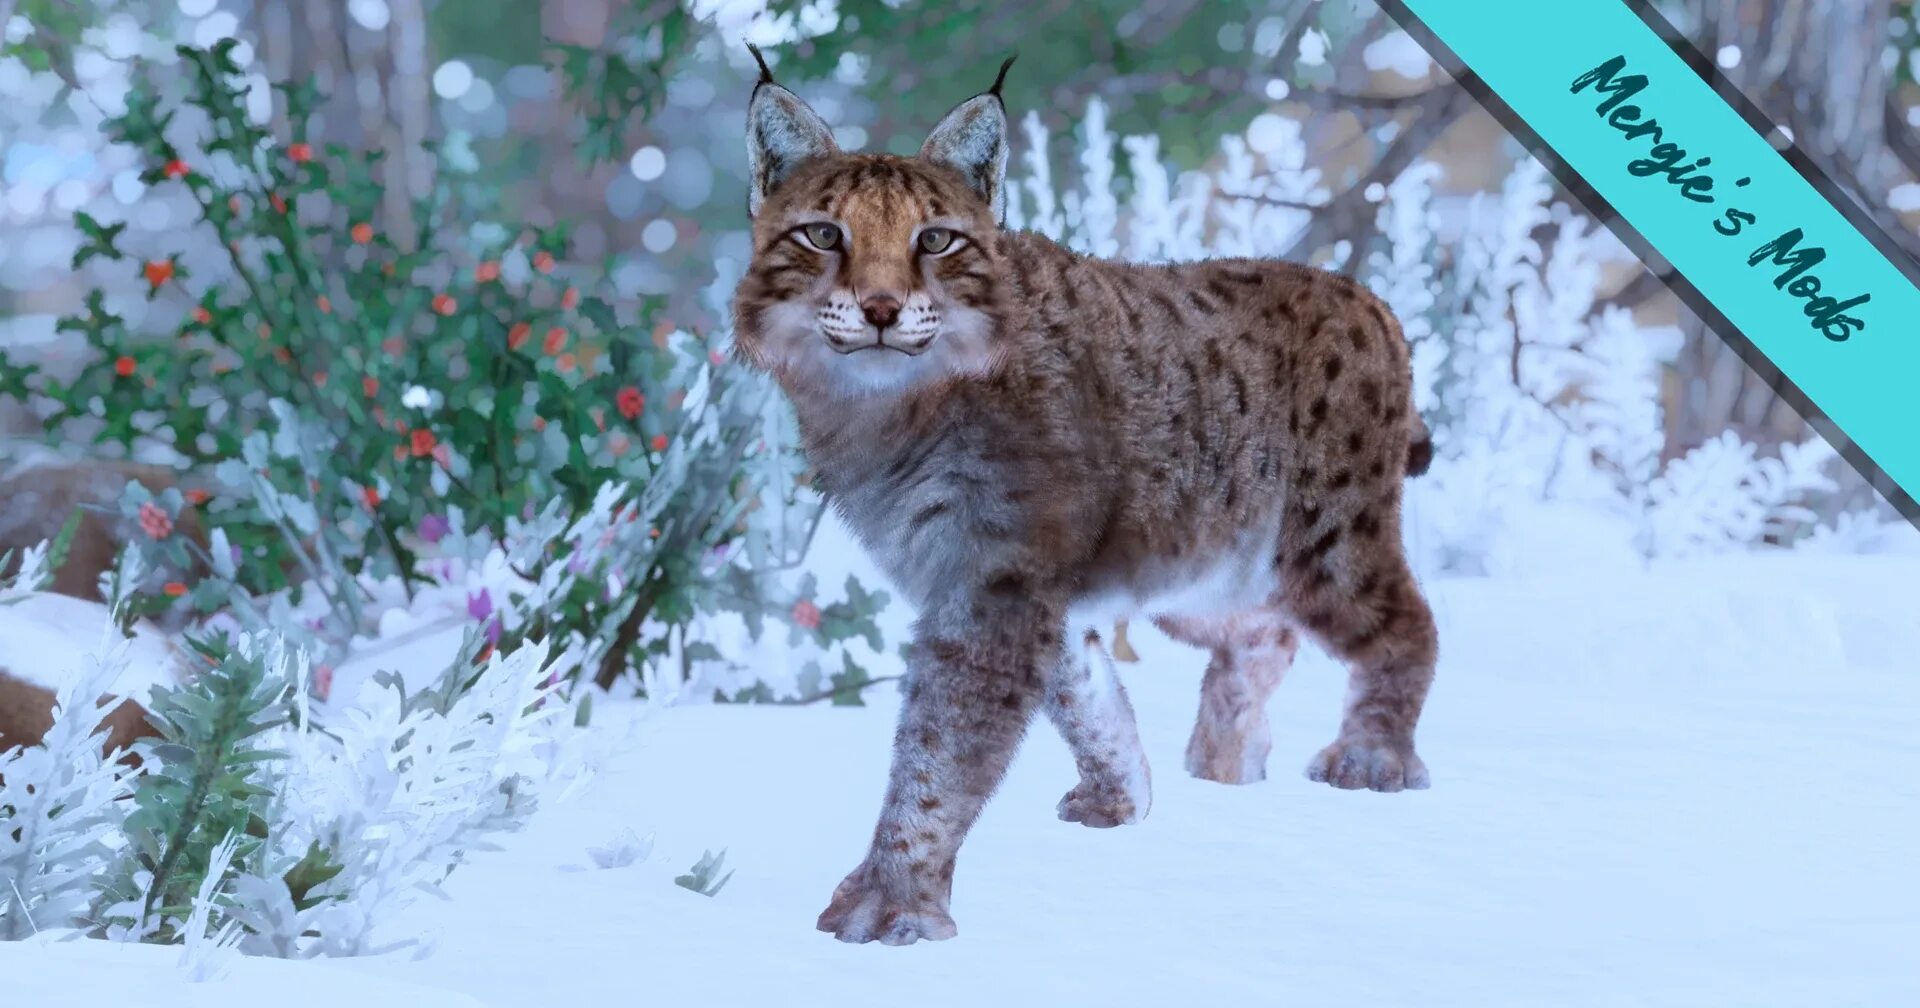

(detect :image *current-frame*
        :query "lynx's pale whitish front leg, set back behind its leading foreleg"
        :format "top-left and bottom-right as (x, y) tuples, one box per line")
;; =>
(1046, 630), (1154, 829)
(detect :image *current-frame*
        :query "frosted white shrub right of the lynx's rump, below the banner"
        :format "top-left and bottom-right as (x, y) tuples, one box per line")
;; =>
(1371, 157), (1834, 572)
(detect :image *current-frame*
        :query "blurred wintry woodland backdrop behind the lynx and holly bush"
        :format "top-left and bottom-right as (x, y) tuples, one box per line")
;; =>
(0, 0), (1920, 695)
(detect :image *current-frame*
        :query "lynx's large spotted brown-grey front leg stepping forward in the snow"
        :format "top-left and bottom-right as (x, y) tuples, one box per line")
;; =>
(820, 593), (1062, 945)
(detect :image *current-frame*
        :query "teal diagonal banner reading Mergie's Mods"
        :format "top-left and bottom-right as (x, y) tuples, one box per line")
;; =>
(1386, 0), (1920, 503)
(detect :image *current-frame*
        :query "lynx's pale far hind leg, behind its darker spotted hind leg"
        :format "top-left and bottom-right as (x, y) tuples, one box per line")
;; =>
(1154, 609), (1300, 783)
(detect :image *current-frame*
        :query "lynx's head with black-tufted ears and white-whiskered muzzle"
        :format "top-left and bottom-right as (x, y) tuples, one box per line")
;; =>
(733, 64), (1006, 397)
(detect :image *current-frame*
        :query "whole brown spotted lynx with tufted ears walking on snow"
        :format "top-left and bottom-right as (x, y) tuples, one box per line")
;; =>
(733, 50), (1438, 945)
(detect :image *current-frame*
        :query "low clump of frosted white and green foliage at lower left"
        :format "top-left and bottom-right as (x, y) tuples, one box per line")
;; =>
(0, 518), (599, 952)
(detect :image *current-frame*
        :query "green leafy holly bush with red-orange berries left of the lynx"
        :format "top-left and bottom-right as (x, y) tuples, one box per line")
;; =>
(0, 42), (885, 698)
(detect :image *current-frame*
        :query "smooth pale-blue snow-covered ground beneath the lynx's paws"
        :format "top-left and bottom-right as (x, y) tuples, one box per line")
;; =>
(0, 557), (1920, 1008)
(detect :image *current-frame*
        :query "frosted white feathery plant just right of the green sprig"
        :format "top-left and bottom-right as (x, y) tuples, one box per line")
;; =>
(232, 634), (568, 956)
